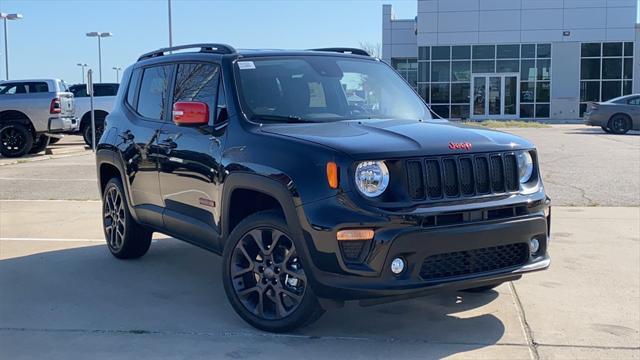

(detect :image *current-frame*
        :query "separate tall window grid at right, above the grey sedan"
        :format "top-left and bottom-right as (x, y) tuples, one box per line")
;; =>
(580, 42), (633, 117)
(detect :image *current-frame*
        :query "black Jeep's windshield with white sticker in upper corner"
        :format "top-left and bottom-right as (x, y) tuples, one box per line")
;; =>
(236, 56), (431, 123)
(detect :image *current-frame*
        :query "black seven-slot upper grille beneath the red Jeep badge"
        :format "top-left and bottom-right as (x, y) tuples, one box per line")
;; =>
(407, 153), (519, 200)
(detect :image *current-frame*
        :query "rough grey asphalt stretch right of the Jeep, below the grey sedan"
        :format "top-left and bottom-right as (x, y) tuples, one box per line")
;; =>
(507, 125), (640, 206)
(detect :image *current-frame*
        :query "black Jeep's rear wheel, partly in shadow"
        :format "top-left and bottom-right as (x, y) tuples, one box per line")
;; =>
(102, 178), (153, 259)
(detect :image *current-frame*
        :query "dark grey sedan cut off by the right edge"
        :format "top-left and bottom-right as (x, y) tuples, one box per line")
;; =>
(584, 94), (640, 134)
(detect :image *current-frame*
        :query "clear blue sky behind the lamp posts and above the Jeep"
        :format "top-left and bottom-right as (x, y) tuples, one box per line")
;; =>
(0, 0), (417, 84)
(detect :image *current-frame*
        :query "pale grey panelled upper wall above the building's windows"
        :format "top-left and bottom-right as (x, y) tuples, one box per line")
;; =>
(417, 0), (637, 46)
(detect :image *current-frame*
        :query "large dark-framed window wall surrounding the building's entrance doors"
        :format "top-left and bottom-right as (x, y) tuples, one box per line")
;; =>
(416, 44), (551, 119)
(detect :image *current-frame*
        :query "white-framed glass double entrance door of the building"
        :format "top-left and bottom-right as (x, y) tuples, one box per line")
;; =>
(471, 74), (520, 119)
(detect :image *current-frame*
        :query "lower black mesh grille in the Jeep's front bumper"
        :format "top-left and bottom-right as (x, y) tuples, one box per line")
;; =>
(420, 243), (529, 281)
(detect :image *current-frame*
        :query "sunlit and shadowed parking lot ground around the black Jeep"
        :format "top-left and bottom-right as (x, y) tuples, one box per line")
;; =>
(0, 125), (640, 359)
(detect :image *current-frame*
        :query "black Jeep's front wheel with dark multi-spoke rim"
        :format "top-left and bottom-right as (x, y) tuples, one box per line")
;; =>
(222, 211), (324, 332)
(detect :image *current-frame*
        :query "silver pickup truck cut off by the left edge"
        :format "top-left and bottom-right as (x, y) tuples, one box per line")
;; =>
(0, 79), (78, 157)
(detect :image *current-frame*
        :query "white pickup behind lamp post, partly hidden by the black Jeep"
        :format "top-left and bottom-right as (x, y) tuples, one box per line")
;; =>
(69, 83), (119, 146)
